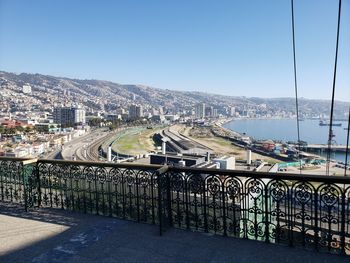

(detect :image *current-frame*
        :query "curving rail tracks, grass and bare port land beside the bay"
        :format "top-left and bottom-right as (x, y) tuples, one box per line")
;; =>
(58, 122), (350, 175)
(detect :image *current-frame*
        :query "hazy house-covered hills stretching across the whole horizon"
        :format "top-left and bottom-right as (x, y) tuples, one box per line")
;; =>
(0, 71), (349, 117)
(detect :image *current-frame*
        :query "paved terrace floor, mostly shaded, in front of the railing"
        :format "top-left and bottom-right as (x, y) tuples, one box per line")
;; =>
(0, 204), (350, 263)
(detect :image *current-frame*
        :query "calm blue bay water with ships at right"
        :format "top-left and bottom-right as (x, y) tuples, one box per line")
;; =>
(224, 119), (350, 162)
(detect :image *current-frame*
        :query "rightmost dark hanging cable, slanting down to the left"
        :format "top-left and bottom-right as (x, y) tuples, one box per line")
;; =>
(326, 0), (341, 175)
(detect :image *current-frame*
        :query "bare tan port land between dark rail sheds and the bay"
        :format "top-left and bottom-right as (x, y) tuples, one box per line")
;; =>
(159, 122), (350, 176)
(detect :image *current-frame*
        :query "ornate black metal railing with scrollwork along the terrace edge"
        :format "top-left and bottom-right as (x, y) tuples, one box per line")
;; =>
(0, 158), (350, 254)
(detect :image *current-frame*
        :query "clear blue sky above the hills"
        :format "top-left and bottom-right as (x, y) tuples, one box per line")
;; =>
(0, 0), (350, 101)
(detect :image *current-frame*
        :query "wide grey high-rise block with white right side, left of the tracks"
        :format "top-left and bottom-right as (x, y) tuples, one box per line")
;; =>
(53, 107), (85, 127)
